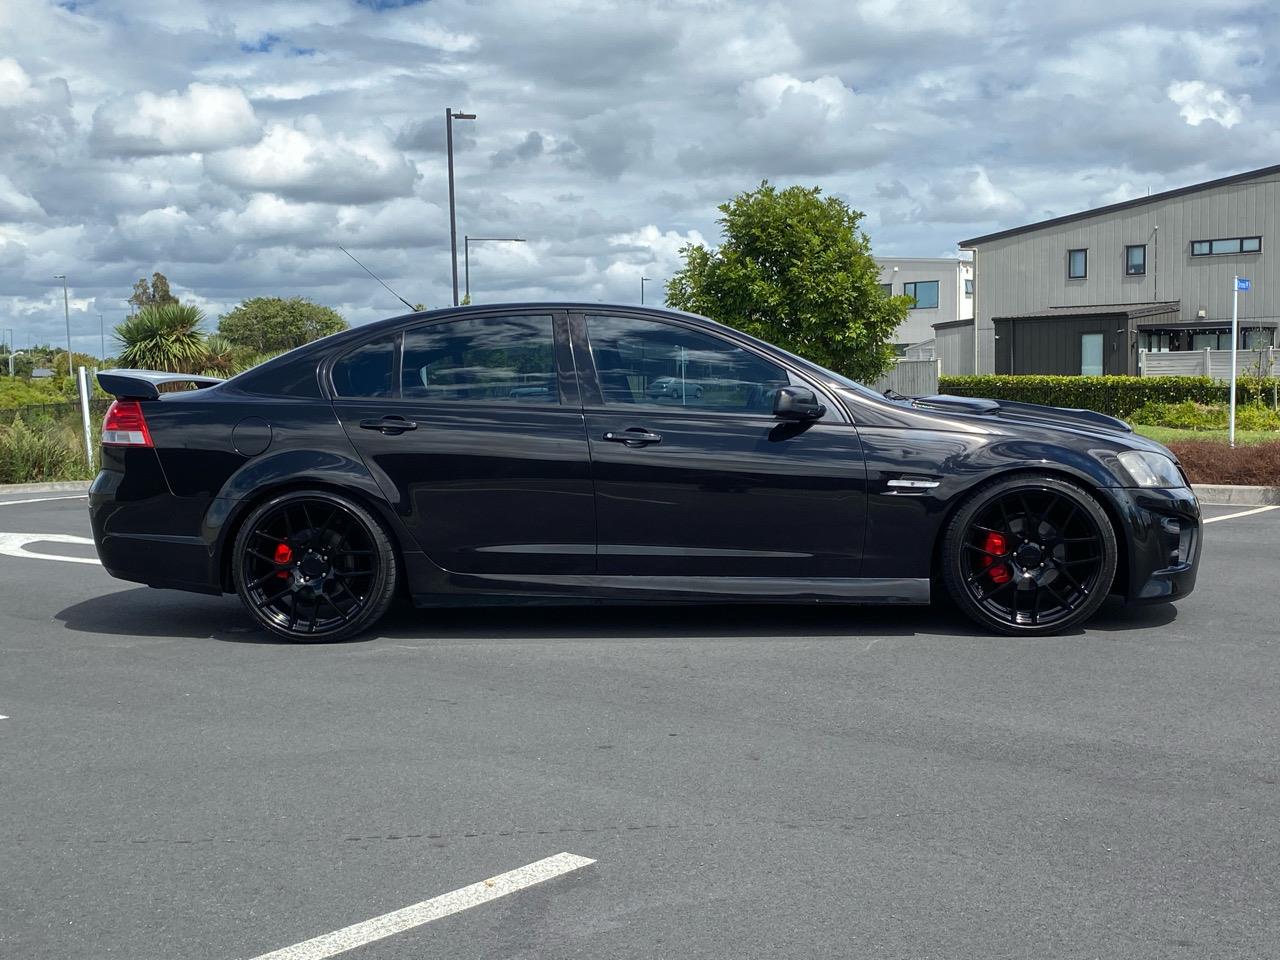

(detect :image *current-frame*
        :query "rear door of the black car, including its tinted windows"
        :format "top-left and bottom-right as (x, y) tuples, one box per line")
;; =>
(330, 310), (595, 573)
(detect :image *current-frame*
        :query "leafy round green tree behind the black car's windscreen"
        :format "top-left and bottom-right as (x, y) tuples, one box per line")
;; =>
(667, 180), (911, 381)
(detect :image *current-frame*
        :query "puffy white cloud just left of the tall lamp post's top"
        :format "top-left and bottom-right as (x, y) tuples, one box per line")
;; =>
(205, 116), (417, 204)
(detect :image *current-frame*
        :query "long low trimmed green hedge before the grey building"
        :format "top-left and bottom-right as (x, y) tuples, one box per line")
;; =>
(938, 375), (1280, 419)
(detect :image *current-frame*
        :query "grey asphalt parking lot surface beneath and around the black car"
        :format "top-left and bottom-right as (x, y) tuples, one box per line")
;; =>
(0, 494), (1280, 960)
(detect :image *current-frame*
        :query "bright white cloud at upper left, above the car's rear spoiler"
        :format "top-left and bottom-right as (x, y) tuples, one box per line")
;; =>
(91, 83), (261, 156)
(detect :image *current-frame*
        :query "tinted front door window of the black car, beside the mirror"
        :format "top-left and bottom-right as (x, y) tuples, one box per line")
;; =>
(586, 316), (790, 413)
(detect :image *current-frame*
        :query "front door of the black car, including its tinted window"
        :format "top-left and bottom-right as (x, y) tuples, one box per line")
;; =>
(573, 315), (867, 579)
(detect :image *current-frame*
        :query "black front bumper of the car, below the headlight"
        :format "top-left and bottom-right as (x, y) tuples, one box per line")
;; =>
(1110, 486), (1203, 604)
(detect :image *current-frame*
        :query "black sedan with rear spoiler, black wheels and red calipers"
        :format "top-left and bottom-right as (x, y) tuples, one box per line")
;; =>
(90, 303), (1201, 640)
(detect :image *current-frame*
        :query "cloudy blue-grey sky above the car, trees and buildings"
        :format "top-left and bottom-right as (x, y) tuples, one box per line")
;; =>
(0, 0), (1280, 355)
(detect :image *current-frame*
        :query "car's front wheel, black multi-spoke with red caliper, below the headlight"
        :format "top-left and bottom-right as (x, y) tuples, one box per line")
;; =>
(942, 475), (1117, 635)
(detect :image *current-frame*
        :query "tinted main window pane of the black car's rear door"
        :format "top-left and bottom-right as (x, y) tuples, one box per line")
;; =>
(401, 316), (559, 403)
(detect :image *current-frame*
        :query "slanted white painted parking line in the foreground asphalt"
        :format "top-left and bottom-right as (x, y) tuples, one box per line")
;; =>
(253, 854), (595, 960)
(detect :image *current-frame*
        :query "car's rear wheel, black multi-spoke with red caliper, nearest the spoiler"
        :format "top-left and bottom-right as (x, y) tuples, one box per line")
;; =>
(232, 490), (399, 641)
